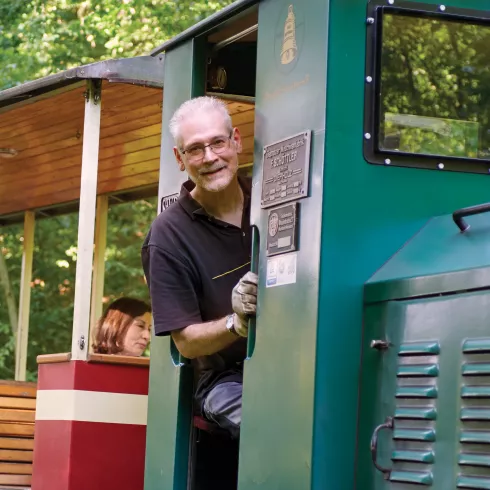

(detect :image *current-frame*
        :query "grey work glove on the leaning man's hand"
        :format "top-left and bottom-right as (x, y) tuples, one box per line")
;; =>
(231, 272), (259, 337)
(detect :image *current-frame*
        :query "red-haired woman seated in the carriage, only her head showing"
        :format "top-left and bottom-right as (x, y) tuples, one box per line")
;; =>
(92, 298), (151, 357)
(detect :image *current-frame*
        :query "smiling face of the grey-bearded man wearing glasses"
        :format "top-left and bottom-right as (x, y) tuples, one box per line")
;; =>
(174, 111), (241, 192)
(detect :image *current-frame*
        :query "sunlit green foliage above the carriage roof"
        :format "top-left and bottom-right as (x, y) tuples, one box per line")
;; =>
(0, 0), (231, 88)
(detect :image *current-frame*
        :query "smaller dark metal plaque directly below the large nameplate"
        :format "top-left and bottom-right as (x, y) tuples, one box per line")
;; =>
(267, 202), (298, 256)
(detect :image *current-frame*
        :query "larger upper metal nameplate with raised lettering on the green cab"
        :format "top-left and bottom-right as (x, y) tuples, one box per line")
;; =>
(261, 130), (311, 208)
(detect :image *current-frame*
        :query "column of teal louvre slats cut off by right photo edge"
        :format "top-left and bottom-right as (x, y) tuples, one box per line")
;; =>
(457, 338), (490, 490)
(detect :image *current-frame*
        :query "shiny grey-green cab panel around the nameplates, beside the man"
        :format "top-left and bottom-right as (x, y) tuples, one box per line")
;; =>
(239, 0), (330, 490)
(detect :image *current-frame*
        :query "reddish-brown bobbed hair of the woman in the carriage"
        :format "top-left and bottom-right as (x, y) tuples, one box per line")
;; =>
(92, 298), (151, 354)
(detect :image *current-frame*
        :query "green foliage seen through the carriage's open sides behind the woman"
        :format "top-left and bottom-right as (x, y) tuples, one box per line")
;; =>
(0, 198), (156, 380)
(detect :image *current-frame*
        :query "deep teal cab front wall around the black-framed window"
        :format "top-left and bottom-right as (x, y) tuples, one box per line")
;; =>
(316, 0), (489, 490)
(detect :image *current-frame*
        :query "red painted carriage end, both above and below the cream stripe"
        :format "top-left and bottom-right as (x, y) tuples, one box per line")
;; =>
(32, 361), (149, 490)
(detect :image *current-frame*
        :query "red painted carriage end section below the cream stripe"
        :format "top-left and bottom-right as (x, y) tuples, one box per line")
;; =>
(32, 420), (146, 490)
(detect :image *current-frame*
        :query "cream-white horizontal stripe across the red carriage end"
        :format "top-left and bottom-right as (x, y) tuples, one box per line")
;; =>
(36, 390), (148, 425)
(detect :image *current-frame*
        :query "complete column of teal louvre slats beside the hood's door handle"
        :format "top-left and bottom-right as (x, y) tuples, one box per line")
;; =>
(390, 342), (440, 488)
